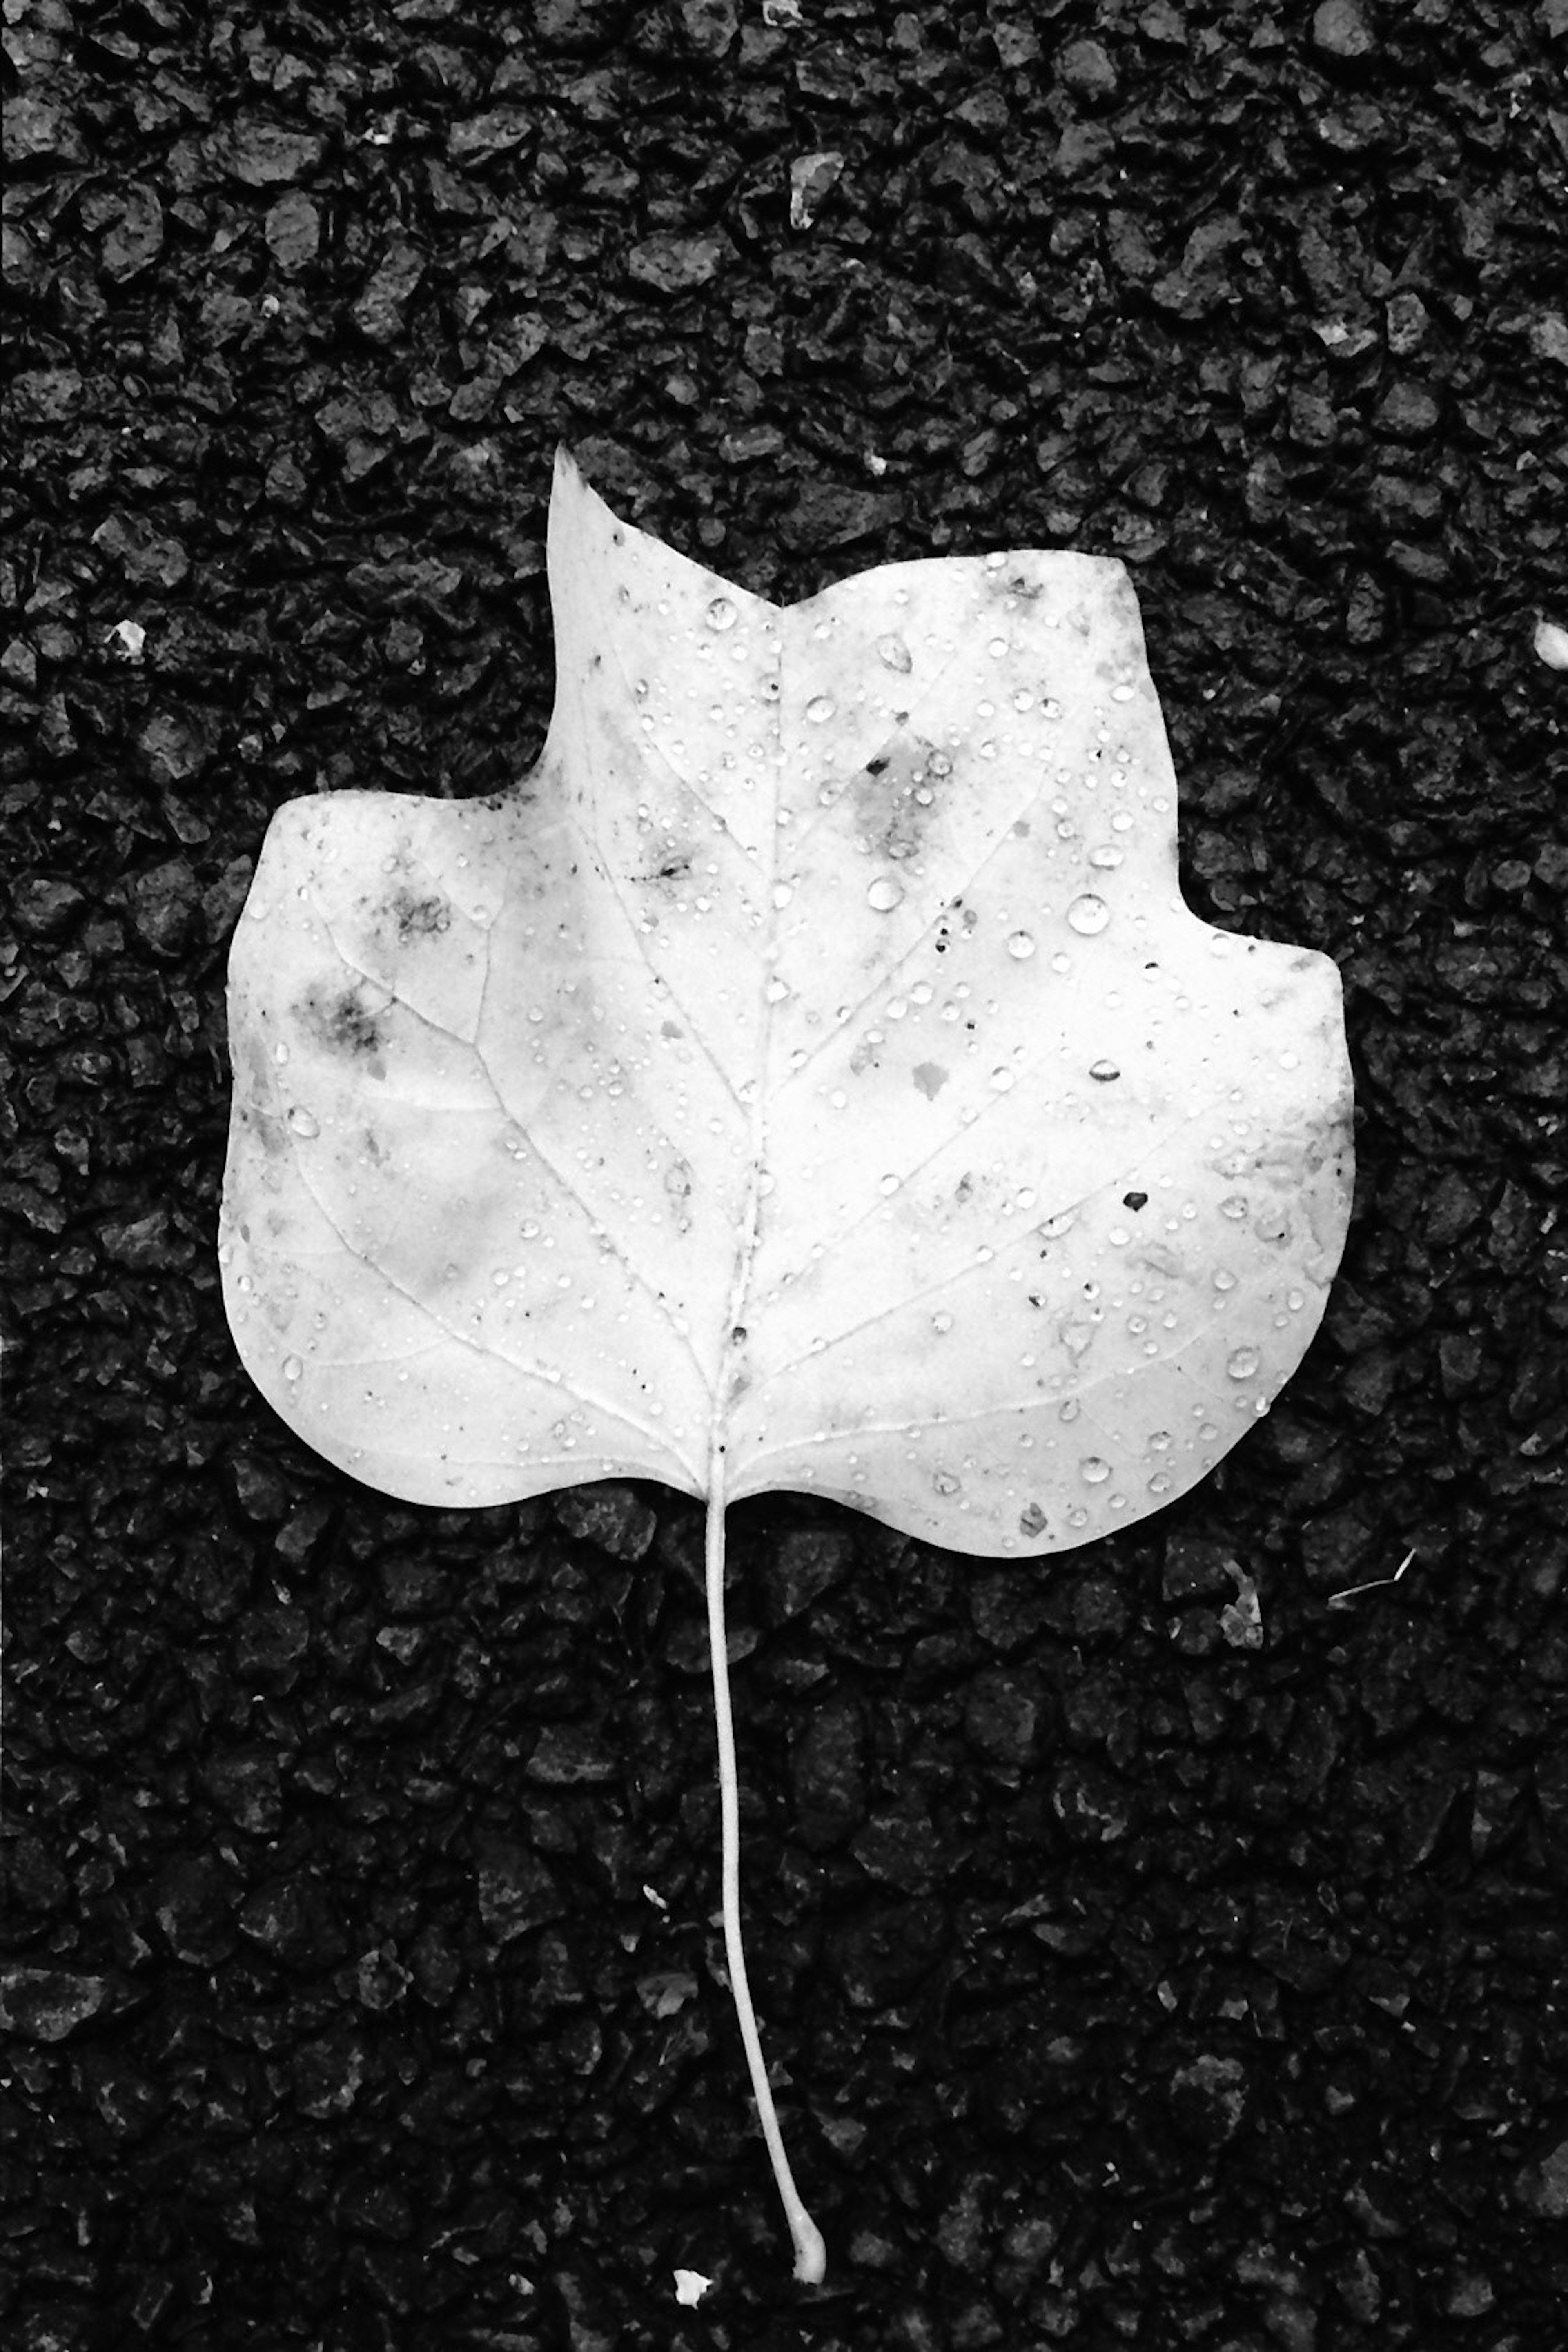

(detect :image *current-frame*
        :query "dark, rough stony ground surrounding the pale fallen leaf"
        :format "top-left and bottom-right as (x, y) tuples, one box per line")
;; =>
(0, 0), (1568, 2352)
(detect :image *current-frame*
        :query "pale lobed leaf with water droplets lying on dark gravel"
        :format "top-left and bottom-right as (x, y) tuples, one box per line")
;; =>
(221, 452), (1352, 2276)
